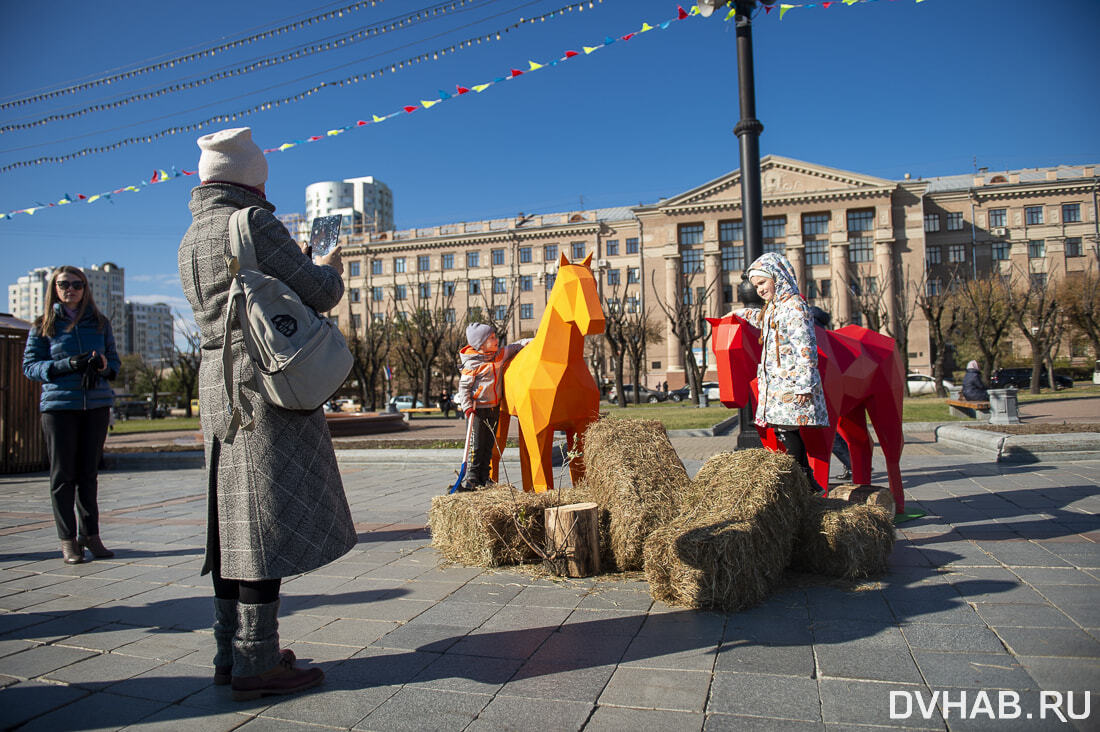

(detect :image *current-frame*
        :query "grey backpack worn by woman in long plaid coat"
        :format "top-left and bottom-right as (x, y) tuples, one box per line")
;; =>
(221, 208), (353, 444)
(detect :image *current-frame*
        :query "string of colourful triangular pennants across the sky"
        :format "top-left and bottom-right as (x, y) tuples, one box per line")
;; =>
(0, 0), (924, 220)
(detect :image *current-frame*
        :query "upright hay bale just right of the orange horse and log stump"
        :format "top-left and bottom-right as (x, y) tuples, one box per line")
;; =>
(584, 418), (690, 571)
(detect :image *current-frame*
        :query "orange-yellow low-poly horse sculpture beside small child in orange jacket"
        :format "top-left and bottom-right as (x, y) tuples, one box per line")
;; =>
(490, 254), (604, 493)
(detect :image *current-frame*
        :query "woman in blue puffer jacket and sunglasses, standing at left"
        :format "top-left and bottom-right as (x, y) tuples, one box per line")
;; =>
(23, 265), (121, 565)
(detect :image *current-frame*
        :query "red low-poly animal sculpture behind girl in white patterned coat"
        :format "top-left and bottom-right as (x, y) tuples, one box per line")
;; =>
(708, 314), (905, 513)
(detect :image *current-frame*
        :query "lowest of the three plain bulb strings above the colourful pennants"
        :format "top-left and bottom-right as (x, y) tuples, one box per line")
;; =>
(0, 0), (604, 173)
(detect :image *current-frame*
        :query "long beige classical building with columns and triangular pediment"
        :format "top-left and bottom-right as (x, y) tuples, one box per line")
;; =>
(330, 155), (1100, 389)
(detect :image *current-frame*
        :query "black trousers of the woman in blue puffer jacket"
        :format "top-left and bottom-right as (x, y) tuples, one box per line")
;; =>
(42, 406), (111, 540)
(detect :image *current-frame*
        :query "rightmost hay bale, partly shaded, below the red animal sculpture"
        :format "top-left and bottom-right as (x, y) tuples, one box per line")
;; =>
(791, 498), (894, 579)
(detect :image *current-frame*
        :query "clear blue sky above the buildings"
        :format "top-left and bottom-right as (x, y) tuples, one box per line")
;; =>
(0, 0), (1100, 319)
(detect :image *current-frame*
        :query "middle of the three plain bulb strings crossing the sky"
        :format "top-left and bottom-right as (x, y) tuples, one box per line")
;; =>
(0, 0), (476, 134)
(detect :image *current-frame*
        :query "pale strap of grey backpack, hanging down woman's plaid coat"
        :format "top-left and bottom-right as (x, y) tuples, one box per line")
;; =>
(221, 206), (257, 445)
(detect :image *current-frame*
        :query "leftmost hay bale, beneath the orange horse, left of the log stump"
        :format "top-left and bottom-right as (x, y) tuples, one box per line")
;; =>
(428, 483), (589, 567)
